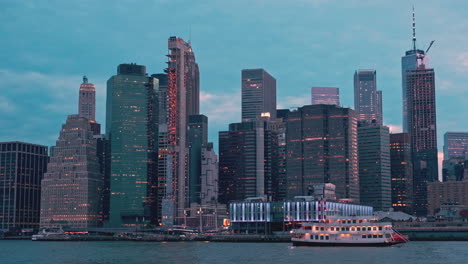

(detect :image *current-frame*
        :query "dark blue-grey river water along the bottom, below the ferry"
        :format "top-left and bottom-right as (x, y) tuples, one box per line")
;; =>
(0, 240), (468, 264)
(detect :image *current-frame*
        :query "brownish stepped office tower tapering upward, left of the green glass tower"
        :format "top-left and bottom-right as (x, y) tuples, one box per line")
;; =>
(41, 115), (103, 228)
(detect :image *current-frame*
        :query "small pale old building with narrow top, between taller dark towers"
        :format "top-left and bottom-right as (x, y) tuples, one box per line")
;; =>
(200, 142), (219, 204)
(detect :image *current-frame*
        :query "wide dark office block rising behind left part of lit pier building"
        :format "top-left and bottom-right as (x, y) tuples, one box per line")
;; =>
(219, 120), (278, 203)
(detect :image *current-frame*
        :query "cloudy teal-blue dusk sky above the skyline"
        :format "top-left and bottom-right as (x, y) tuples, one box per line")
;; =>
(0, 0), (468, 173)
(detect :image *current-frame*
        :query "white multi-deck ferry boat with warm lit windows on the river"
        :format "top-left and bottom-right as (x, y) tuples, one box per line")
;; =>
(291, 217), (408, 247)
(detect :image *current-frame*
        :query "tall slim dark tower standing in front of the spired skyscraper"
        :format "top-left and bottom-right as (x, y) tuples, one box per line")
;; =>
(406, 64), (438, 216)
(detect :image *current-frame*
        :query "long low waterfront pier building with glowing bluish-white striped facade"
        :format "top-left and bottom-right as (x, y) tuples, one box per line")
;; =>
(229, 196), (373, 234)
